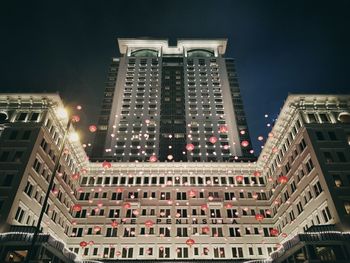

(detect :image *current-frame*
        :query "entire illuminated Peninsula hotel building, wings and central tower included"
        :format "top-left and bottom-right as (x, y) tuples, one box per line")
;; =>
(0, 39), (350, 262)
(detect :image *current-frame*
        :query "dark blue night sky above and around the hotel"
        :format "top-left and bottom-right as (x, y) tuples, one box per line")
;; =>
(0, 0), (350, 153)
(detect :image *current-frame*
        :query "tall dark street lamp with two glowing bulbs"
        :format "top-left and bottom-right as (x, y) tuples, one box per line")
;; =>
(24, 108), (79, 263)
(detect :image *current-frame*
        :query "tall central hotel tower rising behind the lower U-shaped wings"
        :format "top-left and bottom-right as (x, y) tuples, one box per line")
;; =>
(91, 39), (254, 162)
